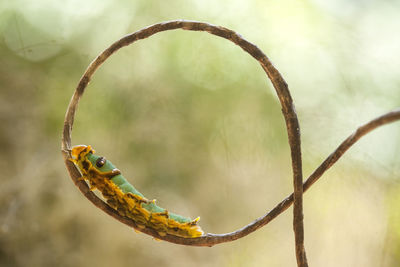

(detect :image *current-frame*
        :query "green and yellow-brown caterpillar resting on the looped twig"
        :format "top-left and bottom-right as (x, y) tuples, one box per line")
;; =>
(71, 145), (204, 238)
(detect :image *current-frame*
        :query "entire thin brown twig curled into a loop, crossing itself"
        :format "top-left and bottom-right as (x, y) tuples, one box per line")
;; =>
(62, 18), (400, 266)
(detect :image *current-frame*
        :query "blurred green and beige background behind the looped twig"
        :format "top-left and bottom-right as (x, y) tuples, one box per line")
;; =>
(0, 0), (400, 266)
